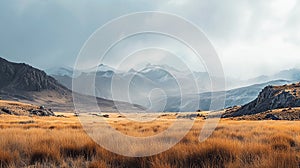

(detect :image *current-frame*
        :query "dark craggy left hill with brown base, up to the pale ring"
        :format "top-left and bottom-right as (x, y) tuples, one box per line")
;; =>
(0, 58), (72, 110)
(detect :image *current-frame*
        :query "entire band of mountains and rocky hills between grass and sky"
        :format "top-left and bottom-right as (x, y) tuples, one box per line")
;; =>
(0, 55), (300, 116)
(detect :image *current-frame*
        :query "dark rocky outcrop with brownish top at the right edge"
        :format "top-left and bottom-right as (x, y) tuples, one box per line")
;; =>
(224, 83), (300, 117)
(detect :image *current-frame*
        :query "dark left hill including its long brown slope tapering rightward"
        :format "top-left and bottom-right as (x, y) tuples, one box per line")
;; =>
(0, 58), (142, 111)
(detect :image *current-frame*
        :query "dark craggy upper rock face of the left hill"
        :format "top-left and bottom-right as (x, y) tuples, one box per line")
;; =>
(0, 58), (65, 92)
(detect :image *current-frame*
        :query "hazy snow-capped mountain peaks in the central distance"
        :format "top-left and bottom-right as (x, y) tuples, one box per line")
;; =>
(47, 64), (210, 107)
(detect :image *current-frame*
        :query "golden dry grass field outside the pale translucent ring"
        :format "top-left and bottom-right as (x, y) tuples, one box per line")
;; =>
(0, 113), (300, 168)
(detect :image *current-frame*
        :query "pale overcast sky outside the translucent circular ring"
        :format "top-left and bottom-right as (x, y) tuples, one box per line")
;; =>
(0, 0), (300, 78)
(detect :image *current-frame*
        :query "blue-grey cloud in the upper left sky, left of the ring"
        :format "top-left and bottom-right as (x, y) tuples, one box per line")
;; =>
(0, 0), (157, 69)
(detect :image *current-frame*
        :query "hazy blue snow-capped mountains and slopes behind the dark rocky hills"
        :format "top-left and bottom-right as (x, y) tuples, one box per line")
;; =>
(47, 64), (300, 111)
